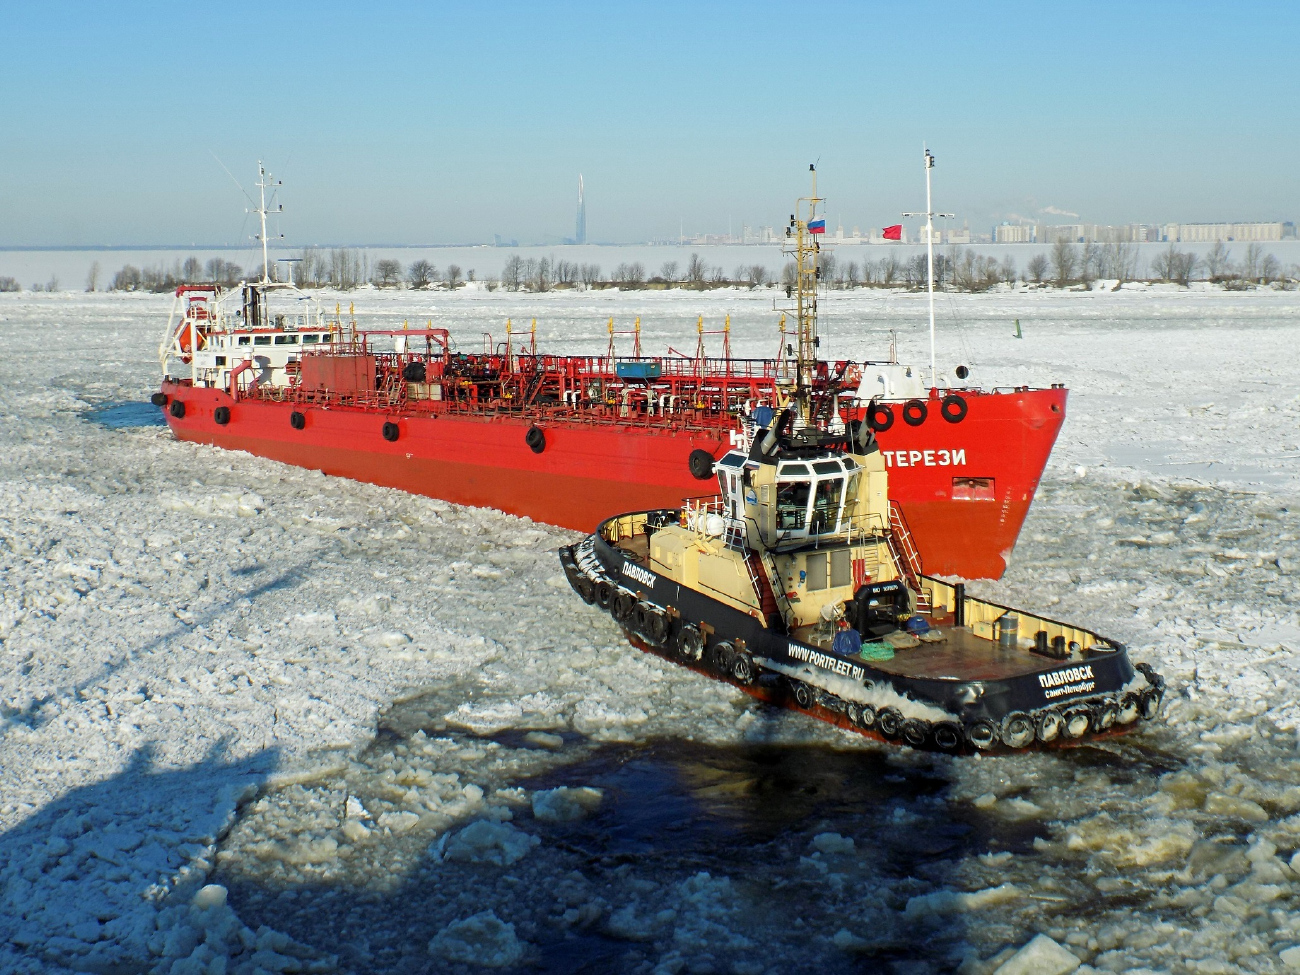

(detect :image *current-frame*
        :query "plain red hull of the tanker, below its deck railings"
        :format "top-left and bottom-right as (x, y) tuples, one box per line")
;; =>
(161, 381), (1066, 579)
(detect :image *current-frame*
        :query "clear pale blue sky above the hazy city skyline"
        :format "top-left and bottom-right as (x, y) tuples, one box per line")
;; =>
(0, 0), (1300, 246)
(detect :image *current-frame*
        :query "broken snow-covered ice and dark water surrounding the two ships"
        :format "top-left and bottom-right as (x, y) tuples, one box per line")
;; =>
(0, 286), (1300, 972)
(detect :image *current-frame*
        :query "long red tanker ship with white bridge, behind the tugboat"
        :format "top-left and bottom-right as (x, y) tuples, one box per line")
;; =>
(153, 162), (1066, 579)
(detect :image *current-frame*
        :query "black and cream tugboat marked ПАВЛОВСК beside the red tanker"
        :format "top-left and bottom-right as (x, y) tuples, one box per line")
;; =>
(559, 175), (1165, 753)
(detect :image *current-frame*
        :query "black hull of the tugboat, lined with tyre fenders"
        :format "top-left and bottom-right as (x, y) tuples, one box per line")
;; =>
(559, 520), (1164, 753)
